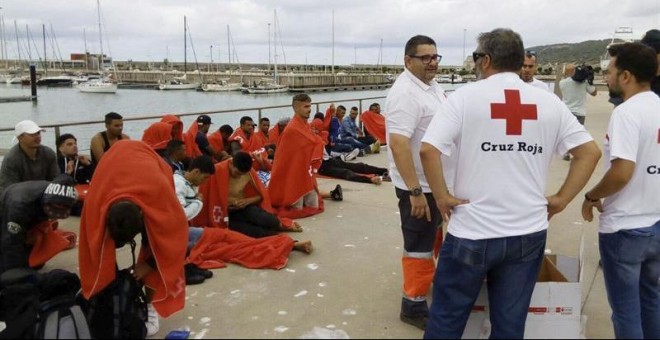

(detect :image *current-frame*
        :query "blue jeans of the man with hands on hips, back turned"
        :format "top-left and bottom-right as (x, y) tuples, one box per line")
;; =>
(424, 230), (547, 339)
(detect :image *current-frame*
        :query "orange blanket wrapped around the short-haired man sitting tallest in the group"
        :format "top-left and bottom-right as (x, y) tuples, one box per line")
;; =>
(268, 115), (323, 218)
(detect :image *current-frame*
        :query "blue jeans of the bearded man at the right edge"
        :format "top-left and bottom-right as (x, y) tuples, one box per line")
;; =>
(598, 221), (660, 339)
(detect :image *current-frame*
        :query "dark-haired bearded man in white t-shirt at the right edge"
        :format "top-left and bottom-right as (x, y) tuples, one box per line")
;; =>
(582, 43), (660, 339)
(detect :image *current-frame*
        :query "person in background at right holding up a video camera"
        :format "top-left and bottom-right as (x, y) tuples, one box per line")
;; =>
(559, 64), (598, 161)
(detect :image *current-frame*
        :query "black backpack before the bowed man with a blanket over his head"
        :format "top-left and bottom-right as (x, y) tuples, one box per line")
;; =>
(79, 241), (147, 339)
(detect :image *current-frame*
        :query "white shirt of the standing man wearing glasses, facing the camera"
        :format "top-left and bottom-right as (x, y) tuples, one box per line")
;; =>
(385, 69), (447, 192)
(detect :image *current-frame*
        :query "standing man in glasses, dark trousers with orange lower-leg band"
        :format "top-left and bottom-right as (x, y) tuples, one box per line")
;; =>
(385, 35), (446, 329)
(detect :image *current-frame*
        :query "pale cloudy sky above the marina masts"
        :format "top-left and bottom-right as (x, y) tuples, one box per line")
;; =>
(0, 0), (660, 65)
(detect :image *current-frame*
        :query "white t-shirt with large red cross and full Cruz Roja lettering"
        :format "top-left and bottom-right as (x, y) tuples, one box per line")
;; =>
(422, 72), (593, 240)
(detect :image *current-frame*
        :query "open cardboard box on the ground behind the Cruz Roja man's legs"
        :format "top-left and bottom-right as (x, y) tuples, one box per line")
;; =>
(463, 238), (584, 339)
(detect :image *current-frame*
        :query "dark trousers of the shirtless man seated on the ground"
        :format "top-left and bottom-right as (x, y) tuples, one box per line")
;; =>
(229, 204), (282, 238)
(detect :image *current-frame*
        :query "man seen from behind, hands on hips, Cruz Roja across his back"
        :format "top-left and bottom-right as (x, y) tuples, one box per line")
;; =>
(420, 28), (600, 339)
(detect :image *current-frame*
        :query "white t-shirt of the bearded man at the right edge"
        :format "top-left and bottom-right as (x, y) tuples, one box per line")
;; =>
(599, 91), (660, 233)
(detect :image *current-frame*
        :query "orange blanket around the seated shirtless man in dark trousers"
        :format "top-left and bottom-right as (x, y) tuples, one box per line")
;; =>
(191, 159), (293, 228)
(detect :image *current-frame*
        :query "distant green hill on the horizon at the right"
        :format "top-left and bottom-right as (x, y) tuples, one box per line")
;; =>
(527, 39), (632, 68)
